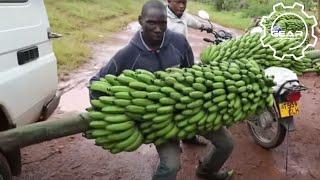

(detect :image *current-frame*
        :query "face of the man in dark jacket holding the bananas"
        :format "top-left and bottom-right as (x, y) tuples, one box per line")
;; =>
(139, 8), (167, 42)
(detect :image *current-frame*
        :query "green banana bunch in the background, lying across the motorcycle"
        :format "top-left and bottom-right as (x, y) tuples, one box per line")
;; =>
(201, 33), (313, 75)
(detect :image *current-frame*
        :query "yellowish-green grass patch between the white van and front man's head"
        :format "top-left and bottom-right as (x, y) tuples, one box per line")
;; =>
(45, 0), (146, 75)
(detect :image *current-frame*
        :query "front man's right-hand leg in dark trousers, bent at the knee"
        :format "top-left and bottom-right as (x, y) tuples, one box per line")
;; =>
(197, 127), (234, 178)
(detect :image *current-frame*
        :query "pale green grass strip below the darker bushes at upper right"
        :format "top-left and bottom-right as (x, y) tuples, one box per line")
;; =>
(188, 1), (251, 30)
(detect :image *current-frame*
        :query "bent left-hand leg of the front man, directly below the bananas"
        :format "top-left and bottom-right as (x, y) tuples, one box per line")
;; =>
(152, 141), (181, 180)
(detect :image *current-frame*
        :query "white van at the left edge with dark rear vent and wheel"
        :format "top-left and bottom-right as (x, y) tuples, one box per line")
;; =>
(0, 0), (60, 180)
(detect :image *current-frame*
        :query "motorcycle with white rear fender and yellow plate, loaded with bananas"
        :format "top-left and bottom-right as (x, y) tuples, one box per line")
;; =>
(198, 10), (307, 149)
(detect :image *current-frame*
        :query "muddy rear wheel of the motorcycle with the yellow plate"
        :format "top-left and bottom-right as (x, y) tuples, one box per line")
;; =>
(247, 109), (287, 149)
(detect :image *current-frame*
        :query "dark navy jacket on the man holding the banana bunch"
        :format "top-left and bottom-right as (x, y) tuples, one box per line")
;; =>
(90, 30), (194, 99)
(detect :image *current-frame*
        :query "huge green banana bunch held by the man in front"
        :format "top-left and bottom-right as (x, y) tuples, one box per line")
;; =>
(87, 58), (274, 153)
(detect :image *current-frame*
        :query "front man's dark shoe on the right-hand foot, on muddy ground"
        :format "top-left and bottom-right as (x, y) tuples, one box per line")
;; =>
(196, 168), (234, 180)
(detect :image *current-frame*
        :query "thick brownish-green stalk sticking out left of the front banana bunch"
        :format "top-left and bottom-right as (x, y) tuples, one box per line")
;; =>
(0, 113), (89, 152)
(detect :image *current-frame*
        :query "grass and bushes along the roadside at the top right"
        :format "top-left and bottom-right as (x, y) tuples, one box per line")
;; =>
(188, 0), (317, 30)
